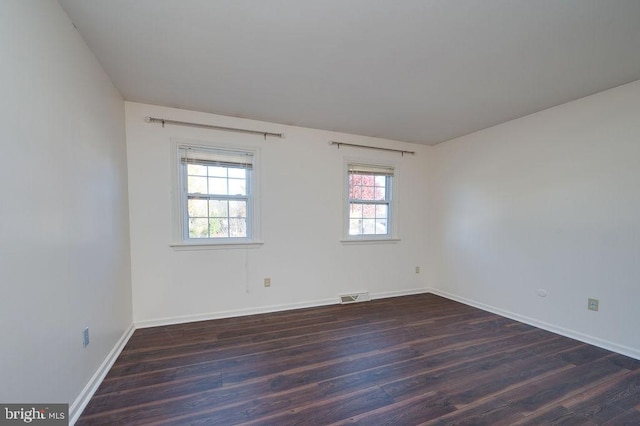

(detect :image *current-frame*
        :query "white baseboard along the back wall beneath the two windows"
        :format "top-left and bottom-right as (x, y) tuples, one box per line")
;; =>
(135, 288), (428, 328)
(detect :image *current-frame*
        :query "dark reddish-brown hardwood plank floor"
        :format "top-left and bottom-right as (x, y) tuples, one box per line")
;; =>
(77, 294), (640, 426)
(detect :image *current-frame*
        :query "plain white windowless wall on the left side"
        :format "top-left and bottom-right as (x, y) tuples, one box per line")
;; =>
(0, 0), (132, 412)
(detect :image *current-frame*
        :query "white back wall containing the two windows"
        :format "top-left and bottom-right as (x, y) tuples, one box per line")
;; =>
(125, 102), (428, 325)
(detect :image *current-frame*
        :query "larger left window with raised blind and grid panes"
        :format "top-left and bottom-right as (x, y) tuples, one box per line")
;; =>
(178, 145), (254, 243)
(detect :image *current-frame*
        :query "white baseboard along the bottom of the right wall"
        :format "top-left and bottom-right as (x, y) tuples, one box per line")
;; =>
(428, 288), (640, 360)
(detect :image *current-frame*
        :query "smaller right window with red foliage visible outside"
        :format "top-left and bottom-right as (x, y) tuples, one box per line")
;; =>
(347, 163), (394, 239)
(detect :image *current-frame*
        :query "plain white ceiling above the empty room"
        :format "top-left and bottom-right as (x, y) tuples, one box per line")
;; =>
(59, 0), (640, 145)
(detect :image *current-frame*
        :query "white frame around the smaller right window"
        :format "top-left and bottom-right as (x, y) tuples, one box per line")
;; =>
(341, 158), (400, 244)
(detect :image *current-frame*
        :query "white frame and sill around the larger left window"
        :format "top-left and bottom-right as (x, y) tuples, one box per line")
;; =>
(170, 140), (262, 250)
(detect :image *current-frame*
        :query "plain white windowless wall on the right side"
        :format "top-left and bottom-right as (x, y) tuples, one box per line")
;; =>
(429, 82), (640, 357)
